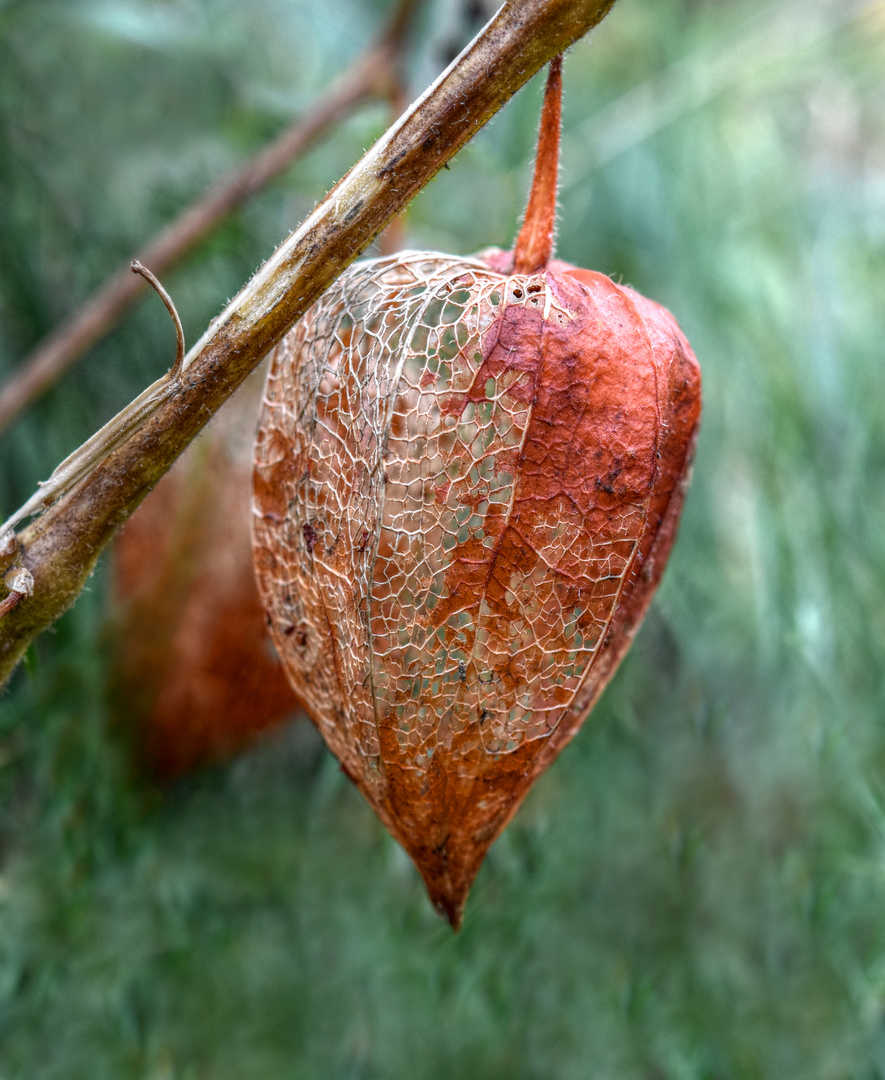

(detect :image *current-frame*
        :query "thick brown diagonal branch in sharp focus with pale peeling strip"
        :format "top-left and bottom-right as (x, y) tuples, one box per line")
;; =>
(0, 0), (614, 681)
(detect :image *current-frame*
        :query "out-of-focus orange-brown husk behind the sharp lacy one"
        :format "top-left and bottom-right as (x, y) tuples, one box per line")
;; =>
(111, 369), (299, 779)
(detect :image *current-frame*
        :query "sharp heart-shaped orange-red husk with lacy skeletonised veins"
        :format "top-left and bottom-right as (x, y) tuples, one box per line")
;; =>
(253, 249), (700, 926)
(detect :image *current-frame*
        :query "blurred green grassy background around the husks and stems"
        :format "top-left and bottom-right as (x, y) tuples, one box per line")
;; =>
(0, 0), (885, 1080)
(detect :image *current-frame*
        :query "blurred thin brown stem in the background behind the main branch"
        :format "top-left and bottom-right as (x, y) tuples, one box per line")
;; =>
(0, 0), (419, 433)
